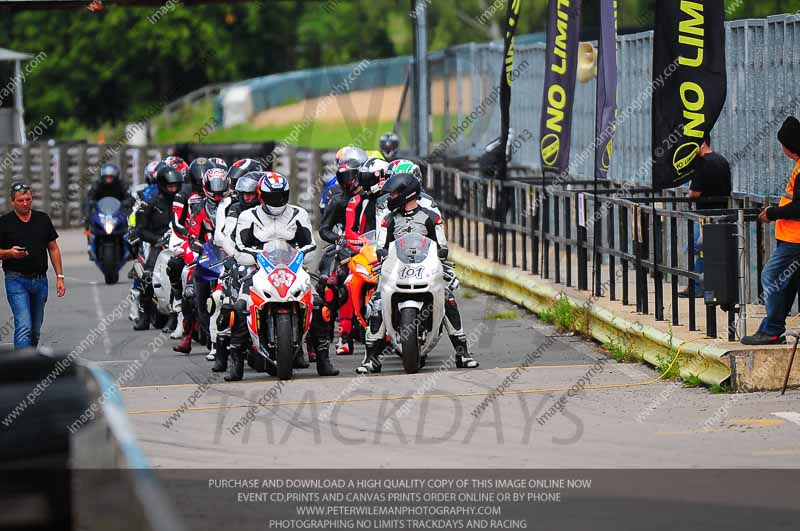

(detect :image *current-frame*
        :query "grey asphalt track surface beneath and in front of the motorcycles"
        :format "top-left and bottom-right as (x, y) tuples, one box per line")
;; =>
(0, 237), (800, 469)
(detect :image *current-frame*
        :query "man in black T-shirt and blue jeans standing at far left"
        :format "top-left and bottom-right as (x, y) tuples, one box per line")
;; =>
(0, 183), (67, 349)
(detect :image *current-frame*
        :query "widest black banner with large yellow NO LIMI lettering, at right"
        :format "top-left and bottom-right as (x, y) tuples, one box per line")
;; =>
(652, 0), (727, 190)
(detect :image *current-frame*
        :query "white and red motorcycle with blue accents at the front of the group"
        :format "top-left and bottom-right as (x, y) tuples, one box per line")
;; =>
(247, 240), (314, 380)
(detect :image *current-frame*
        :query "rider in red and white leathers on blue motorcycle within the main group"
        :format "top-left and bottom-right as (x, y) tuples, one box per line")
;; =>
(172, 168), (230, 354)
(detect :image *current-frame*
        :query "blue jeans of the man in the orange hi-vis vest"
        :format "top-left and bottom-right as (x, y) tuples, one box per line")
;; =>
(758, 241), (800, 336)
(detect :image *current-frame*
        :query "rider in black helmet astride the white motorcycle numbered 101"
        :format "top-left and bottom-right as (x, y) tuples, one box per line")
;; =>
(356, 173), (479, 374)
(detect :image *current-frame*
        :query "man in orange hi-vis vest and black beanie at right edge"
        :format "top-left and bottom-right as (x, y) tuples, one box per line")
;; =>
(742, 116), (800, 345)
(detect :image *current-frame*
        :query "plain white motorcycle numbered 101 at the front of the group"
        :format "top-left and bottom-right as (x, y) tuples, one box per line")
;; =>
(380, 234), (446, 374)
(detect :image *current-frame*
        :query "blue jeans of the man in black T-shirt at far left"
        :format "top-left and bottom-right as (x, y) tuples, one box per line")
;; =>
(5, 272), (47, 349)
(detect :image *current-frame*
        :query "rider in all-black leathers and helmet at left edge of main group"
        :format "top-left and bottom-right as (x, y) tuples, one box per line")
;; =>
(133, 164), (183, 330)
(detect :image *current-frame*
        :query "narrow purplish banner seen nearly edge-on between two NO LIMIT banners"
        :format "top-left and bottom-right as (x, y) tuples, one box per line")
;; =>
(594, 0), (617, 179)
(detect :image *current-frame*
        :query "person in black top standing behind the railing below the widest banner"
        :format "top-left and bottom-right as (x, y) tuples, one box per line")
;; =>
(678, 133), (733, 297)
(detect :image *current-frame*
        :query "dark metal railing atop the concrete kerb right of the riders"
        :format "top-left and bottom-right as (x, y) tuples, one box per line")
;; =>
(427, 164), (770, 340)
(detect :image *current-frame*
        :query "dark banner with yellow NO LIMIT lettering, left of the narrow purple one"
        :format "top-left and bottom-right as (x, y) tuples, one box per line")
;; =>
(539, 0), (581, 179)
